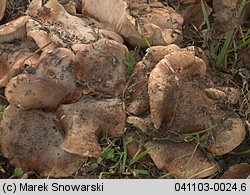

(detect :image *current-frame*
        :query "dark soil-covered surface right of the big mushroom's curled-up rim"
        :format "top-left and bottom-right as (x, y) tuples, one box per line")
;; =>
(162, 78), (217, 133)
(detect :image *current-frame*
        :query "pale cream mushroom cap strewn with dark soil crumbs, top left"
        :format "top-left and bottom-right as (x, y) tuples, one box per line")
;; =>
(27, 0), (97, 49)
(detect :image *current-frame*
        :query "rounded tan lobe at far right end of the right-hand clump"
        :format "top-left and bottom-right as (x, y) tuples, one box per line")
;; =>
(207, 113), (246, 156)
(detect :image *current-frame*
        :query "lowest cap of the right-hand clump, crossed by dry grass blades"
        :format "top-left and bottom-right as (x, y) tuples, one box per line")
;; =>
(146, 141), (218, 179)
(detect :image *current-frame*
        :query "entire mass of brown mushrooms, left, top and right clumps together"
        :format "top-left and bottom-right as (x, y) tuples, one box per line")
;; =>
(0, 0), (246, 178)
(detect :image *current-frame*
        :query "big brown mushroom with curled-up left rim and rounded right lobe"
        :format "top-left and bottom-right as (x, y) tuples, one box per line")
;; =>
(145, 46), (246, 155)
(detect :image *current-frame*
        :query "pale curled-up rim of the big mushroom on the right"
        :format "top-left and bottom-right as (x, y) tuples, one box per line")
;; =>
(148, 51), (206, 129)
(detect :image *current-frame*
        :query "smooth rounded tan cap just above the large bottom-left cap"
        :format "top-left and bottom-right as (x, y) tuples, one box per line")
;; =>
(5, 73), (67, 110)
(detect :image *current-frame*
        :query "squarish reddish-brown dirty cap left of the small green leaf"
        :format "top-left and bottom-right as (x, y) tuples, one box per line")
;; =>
(75, 39), (128, 97)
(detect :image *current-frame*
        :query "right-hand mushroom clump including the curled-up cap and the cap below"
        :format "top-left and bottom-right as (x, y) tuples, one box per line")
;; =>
(127, 44), (246, 178)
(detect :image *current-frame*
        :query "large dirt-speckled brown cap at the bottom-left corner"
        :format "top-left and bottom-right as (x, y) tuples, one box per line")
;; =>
(0, 106), (82, 177)
